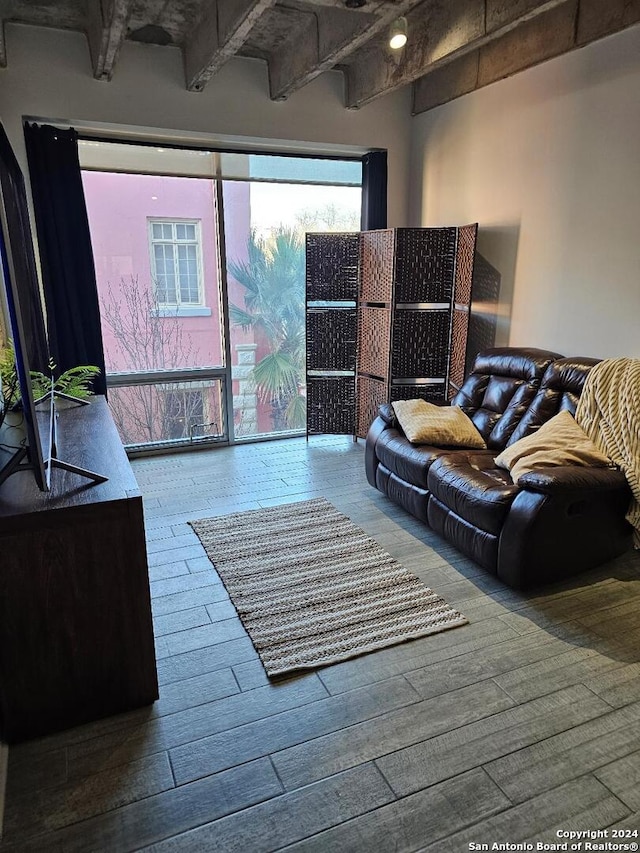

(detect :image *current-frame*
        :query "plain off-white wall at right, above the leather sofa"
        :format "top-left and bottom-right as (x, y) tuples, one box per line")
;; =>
(410, 27), (640, 357)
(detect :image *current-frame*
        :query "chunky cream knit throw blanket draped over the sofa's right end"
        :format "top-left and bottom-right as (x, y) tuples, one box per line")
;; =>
(576, 358), (640, 548)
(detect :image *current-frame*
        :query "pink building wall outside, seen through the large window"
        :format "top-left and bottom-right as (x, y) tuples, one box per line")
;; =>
(83, 171), (272, 442)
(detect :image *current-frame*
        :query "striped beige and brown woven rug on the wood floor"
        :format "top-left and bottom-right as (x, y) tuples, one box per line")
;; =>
(190, 498), (467, 676)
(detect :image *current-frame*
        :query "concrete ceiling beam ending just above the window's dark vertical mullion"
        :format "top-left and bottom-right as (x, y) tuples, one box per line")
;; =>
(184, 0), (276, 92)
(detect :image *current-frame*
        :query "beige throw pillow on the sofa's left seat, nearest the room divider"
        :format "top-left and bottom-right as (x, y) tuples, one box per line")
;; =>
(392, 400), (487, 448)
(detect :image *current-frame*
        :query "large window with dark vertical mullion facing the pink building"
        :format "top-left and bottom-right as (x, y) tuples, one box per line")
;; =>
(79, 140), (362, 451)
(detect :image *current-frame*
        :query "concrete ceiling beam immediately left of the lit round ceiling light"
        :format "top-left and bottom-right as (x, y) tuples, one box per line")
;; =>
(269, 0), (422, 101)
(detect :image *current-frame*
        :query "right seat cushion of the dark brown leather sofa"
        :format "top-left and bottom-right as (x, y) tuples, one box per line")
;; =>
(427, 450), (519, 535)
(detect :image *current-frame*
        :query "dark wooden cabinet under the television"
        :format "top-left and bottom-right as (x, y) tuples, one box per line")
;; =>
(0, 398), (158, 743)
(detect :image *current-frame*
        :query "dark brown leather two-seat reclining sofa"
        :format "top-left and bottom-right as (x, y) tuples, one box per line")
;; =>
(365, 347), (631, 588)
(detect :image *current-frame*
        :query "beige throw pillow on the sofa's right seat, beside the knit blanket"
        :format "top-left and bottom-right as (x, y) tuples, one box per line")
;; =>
(496, 412), (611, 484)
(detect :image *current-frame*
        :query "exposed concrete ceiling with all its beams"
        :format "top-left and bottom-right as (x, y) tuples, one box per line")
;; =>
(0, 0), (640, 113)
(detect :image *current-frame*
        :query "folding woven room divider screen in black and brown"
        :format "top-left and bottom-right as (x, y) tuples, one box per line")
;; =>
(306, 225), (477, 438)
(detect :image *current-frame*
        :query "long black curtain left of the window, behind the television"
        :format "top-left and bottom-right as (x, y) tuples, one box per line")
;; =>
(24, 124), (107, 394)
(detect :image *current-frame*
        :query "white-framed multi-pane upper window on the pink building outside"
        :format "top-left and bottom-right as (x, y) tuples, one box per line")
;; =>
(147, 219), (210, 315)
